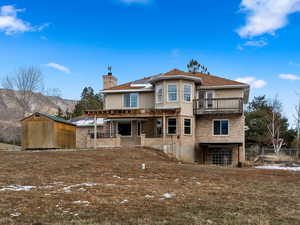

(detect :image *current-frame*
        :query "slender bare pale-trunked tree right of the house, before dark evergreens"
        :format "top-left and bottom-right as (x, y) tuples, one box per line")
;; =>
(266, 96), (284, 154)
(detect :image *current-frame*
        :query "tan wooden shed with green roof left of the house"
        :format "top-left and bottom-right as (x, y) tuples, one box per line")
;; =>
(21, 112), (76, 150)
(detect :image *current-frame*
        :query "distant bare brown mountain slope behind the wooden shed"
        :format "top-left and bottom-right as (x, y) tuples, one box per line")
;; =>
(0, 89), (77, 142)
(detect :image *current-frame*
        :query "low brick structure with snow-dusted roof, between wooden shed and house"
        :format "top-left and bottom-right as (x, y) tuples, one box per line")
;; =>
(70, 116), (114, 149)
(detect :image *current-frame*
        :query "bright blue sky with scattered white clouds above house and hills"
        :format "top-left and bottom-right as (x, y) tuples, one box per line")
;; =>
(0, 0), (300, 125)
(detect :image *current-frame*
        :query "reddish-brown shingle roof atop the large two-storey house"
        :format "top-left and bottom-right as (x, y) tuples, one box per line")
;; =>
(105, 69), (247, 91)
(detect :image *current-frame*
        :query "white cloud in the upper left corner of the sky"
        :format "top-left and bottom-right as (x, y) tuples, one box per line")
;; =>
(0, 5), (49, 35)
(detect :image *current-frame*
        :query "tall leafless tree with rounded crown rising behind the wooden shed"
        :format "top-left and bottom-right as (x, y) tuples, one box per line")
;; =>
(2, 66), (43, 117)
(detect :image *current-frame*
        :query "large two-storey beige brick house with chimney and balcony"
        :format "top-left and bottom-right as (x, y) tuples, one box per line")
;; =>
(87, 69), (249, 165)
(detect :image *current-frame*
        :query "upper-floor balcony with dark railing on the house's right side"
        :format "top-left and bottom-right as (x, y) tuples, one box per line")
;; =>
(194, 98), (243, 115)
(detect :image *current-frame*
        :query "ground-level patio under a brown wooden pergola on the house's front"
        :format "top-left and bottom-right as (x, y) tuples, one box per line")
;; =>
(86, 108), (180, 147)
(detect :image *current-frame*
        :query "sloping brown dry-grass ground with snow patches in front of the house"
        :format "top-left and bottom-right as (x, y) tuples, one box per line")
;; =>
(0, 148), (300, 225)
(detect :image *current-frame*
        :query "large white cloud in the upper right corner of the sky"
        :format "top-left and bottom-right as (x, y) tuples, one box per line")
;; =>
(237, 0), (300, 37)
